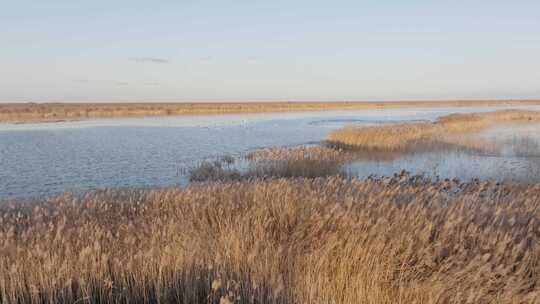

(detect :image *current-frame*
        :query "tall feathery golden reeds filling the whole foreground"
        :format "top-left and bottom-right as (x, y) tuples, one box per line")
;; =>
(0, 176), (540, 304)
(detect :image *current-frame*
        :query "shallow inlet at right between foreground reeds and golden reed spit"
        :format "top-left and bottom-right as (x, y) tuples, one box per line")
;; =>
(346, 125), (540, 183)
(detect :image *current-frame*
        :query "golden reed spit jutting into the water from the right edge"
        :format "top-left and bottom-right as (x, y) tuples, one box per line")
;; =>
(328, 110), (540, 151)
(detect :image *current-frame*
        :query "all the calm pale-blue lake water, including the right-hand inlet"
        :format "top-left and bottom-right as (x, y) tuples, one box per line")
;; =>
(0, 107), (540, 198)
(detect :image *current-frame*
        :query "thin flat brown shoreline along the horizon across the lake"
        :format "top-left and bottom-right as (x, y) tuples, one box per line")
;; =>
(0, 100), (540, 123)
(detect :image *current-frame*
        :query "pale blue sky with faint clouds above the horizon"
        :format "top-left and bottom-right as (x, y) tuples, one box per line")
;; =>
(0, 0), (540, 102)
